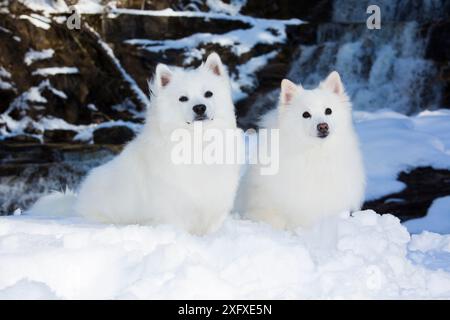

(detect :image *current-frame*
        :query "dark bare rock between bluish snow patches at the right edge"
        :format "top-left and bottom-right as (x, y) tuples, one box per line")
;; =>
(364, 167), (450, 221)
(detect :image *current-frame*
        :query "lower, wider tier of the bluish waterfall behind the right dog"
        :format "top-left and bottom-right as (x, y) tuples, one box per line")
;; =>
(288, 21), (442, 114)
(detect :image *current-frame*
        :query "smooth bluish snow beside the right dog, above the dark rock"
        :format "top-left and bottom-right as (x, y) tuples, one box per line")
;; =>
(355, 110), (450, 200)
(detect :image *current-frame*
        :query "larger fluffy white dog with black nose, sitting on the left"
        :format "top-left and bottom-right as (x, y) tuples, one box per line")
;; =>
(30, 53), (239, 234)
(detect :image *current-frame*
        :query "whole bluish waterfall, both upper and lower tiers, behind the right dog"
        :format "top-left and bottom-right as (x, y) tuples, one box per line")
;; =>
(241, 0), (450, 126)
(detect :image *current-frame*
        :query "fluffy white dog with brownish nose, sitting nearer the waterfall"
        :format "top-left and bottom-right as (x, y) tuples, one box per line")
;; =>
(238, 72), (365, 229)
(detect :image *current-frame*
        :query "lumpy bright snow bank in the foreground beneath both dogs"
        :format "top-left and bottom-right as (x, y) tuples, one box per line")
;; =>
(0, 211), (450, 299)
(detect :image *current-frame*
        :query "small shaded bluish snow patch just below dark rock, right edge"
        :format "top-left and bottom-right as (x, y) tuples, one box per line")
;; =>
(404, 196), (450, 234)
